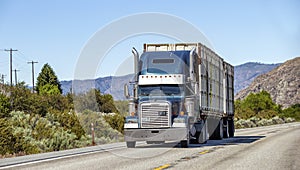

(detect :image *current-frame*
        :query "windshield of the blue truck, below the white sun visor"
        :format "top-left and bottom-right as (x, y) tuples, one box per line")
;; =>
(139, 85), (183, 96)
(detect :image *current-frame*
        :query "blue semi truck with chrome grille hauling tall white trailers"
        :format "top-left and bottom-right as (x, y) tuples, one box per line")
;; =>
(124, 42), (235, 148)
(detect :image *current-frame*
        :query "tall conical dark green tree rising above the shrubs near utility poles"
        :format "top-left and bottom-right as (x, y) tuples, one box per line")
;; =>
(36, 64), (62, 94)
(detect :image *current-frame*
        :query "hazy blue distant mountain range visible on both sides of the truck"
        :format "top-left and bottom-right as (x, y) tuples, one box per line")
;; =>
(61, 62), (280, 100)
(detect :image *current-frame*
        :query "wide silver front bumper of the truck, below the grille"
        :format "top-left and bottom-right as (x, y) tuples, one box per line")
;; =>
(124, 127), (188, 141)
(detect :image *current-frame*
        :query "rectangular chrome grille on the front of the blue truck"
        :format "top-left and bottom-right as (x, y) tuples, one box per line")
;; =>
(141, 103), (170, 128)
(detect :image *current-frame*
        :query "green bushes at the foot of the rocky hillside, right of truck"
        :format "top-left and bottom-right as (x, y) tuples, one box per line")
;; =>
(235, 91), (300, 128)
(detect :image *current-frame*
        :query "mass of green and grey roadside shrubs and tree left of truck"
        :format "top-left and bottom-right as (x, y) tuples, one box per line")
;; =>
(0, 64), (124, 158)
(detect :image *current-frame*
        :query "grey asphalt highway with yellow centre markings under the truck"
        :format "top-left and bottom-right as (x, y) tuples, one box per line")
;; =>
(0, 123), (300, 170)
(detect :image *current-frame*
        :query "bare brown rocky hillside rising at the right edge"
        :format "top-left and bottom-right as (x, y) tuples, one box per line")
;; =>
(235, 57), (300, 108)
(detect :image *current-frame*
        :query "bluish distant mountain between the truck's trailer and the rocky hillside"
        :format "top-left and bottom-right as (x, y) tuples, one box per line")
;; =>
(234, 62), (280, 94)
